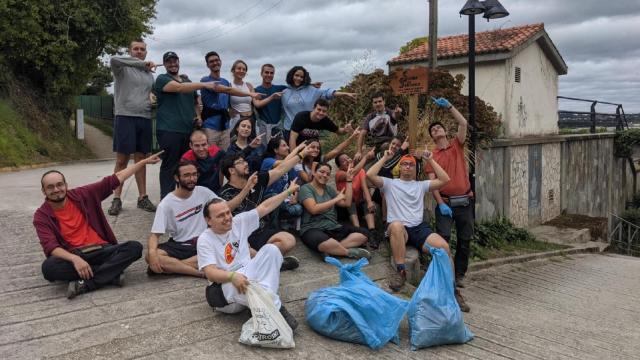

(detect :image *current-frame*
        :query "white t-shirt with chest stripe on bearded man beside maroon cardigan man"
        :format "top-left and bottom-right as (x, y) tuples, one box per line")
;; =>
(151, 186), (219, 242)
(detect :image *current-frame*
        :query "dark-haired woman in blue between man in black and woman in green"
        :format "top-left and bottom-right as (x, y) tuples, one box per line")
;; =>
(260, 136), (304, 227)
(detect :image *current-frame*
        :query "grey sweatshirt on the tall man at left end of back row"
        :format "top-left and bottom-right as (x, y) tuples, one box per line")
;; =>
(110, 56), (153, 119)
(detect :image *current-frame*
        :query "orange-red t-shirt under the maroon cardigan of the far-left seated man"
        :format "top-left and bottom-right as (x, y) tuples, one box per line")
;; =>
(53, 199), (107, 248)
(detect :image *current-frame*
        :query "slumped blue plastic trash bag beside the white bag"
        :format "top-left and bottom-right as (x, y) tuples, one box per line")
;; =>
(305, 257), (409, 350)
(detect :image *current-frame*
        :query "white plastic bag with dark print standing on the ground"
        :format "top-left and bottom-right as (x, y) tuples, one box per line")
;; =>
(239, 282), (296, 349)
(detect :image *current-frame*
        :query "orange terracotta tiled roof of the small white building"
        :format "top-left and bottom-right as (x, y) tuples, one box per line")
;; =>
(388, 23), (544, 65)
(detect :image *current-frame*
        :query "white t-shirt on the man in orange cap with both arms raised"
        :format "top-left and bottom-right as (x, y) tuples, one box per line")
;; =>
(382, 177), (430, 227)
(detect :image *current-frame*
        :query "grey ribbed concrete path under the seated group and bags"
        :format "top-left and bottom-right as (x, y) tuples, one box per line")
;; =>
(0, 161), (640, 360)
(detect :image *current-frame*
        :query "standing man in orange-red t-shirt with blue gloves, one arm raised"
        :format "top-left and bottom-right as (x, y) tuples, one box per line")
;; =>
(425, 98), (475, 307)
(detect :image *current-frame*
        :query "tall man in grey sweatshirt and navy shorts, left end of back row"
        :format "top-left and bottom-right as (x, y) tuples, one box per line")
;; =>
(109, 39), (156, 215)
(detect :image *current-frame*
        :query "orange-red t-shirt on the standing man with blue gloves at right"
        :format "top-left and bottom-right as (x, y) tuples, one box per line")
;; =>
(425, 138), (471, 196)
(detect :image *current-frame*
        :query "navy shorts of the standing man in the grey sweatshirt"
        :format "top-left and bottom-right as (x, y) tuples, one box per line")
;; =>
(113, 115), (153, 155)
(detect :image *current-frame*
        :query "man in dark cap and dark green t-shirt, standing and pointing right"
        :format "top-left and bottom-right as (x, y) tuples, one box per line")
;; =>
(153, 51), (259, 198)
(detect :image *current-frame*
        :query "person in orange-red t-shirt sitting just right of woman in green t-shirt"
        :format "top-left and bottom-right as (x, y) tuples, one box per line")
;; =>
(335, 148), (383, 249)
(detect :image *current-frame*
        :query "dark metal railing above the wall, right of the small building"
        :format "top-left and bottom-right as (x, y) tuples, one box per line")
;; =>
(558, 96), (629, 133)
